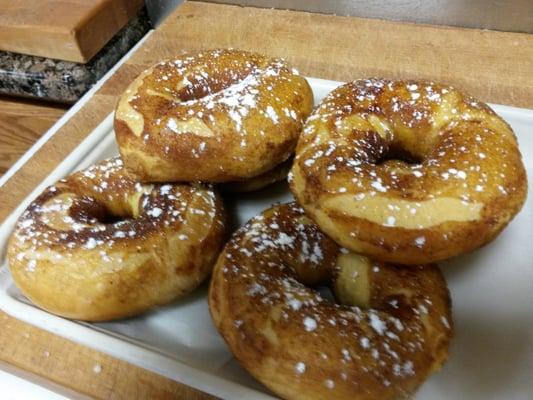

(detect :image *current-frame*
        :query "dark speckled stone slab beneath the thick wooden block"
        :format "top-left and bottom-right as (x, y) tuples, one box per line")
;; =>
(0, 10), (151, 103)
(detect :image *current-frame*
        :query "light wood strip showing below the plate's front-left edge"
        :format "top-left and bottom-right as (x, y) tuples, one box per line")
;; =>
(0, 312), (212, 400)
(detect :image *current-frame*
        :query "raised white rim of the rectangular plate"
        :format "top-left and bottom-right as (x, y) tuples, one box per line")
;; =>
(0, 77), (533, 399)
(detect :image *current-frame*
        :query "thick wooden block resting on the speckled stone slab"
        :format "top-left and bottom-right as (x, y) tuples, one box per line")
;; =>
(0, 0), (144, 63)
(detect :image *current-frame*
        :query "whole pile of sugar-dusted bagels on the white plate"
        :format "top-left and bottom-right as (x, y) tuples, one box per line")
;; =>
(8, 49), (527, 399)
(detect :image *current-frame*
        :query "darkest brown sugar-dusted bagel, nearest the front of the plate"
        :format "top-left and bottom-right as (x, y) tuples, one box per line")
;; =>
(209, 203), (453, 399)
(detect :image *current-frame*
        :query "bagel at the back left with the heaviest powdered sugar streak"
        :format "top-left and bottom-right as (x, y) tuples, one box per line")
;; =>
(114, 50), (313, 182)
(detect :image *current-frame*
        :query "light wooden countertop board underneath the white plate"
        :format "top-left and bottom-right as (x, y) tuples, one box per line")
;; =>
(0, 2), (533, 399)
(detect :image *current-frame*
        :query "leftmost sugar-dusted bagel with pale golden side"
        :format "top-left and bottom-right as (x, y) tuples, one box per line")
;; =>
(8, 158), (224, 321)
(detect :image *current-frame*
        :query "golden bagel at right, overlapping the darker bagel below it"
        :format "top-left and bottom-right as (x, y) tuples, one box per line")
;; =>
(289, 79), (527, 264)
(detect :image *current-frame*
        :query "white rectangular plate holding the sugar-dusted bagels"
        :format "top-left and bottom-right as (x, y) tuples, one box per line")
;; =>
(0, 79), (533, 400)
